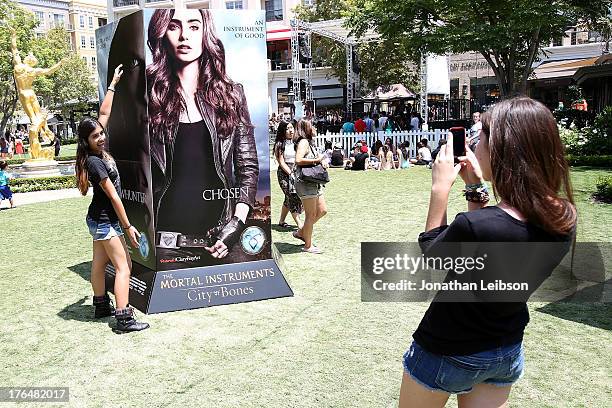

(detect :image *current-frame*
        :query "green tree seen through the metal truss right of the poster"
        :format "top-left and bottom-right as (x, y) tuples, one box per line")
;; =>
(296, 0), (418, 93)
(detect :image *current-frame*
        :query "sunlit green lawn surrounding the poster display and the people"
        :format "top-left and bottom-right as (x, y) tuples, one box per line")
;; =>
(0, 168), (612, 408)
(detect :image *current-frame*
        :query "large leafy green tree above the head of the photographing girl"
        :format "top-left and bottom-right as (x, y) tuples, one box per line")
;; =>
(349, 0), (611, 97)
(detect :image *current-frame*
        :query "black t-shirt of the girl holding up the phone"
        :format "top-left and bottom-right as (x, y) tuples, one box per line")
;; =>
(413, 207), (571, 355)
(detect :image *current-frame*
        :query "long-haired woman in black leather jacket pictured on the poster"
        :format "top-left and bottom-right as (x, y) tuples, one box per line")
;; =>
(146, 9), (259, 261)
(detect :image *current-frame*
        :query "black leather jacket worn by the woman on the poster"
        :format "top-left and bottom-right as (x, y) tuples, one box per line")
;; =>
(150, 84), (259, 236)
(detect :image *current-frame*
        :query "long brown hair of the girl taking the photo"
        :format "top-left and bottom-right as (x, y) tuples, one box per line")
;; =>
(481, 97), (577, 235)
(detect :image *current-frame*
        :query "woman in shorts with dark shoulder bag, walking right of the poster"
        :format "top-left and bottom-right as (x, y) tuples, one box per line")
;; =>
(293, 119), (327, 254)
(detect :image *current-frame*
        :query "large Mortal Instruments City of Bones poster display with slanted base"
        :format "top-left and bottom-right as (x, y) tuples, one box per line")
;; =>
(96, 9), (293, 313)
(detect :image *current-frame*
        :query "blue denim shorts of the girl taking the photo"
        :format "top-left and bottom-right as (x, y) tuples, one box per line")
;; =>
(404, 341), (525, 394)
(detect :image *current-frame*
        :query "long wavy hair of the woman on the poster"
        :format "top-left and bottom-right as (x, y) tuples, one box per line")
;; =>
(147, 9), (253, 143)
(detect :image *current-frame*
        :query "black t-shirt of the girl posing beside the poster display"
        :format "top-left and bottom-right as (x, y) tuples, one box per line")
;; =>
(85, 155), (121, 222)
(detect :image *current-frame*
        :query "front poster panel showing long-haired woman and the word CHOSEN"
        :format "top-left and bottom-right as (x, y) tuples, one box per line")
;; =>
(144, 9), (271, 270)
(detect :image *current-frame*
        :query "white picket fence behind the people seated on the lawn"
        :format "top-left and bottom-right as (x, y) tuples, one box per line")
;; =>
(314, 129), (448, 157)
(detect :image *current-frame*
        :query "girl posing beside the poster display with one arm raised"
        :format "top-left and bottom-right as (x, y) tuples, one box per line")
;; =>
(76, 65), (149, 332)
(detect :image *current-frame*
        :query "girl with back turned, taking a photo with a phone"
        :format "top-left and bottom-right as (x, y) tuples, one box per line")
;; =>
(399, 97), (576, 408)
